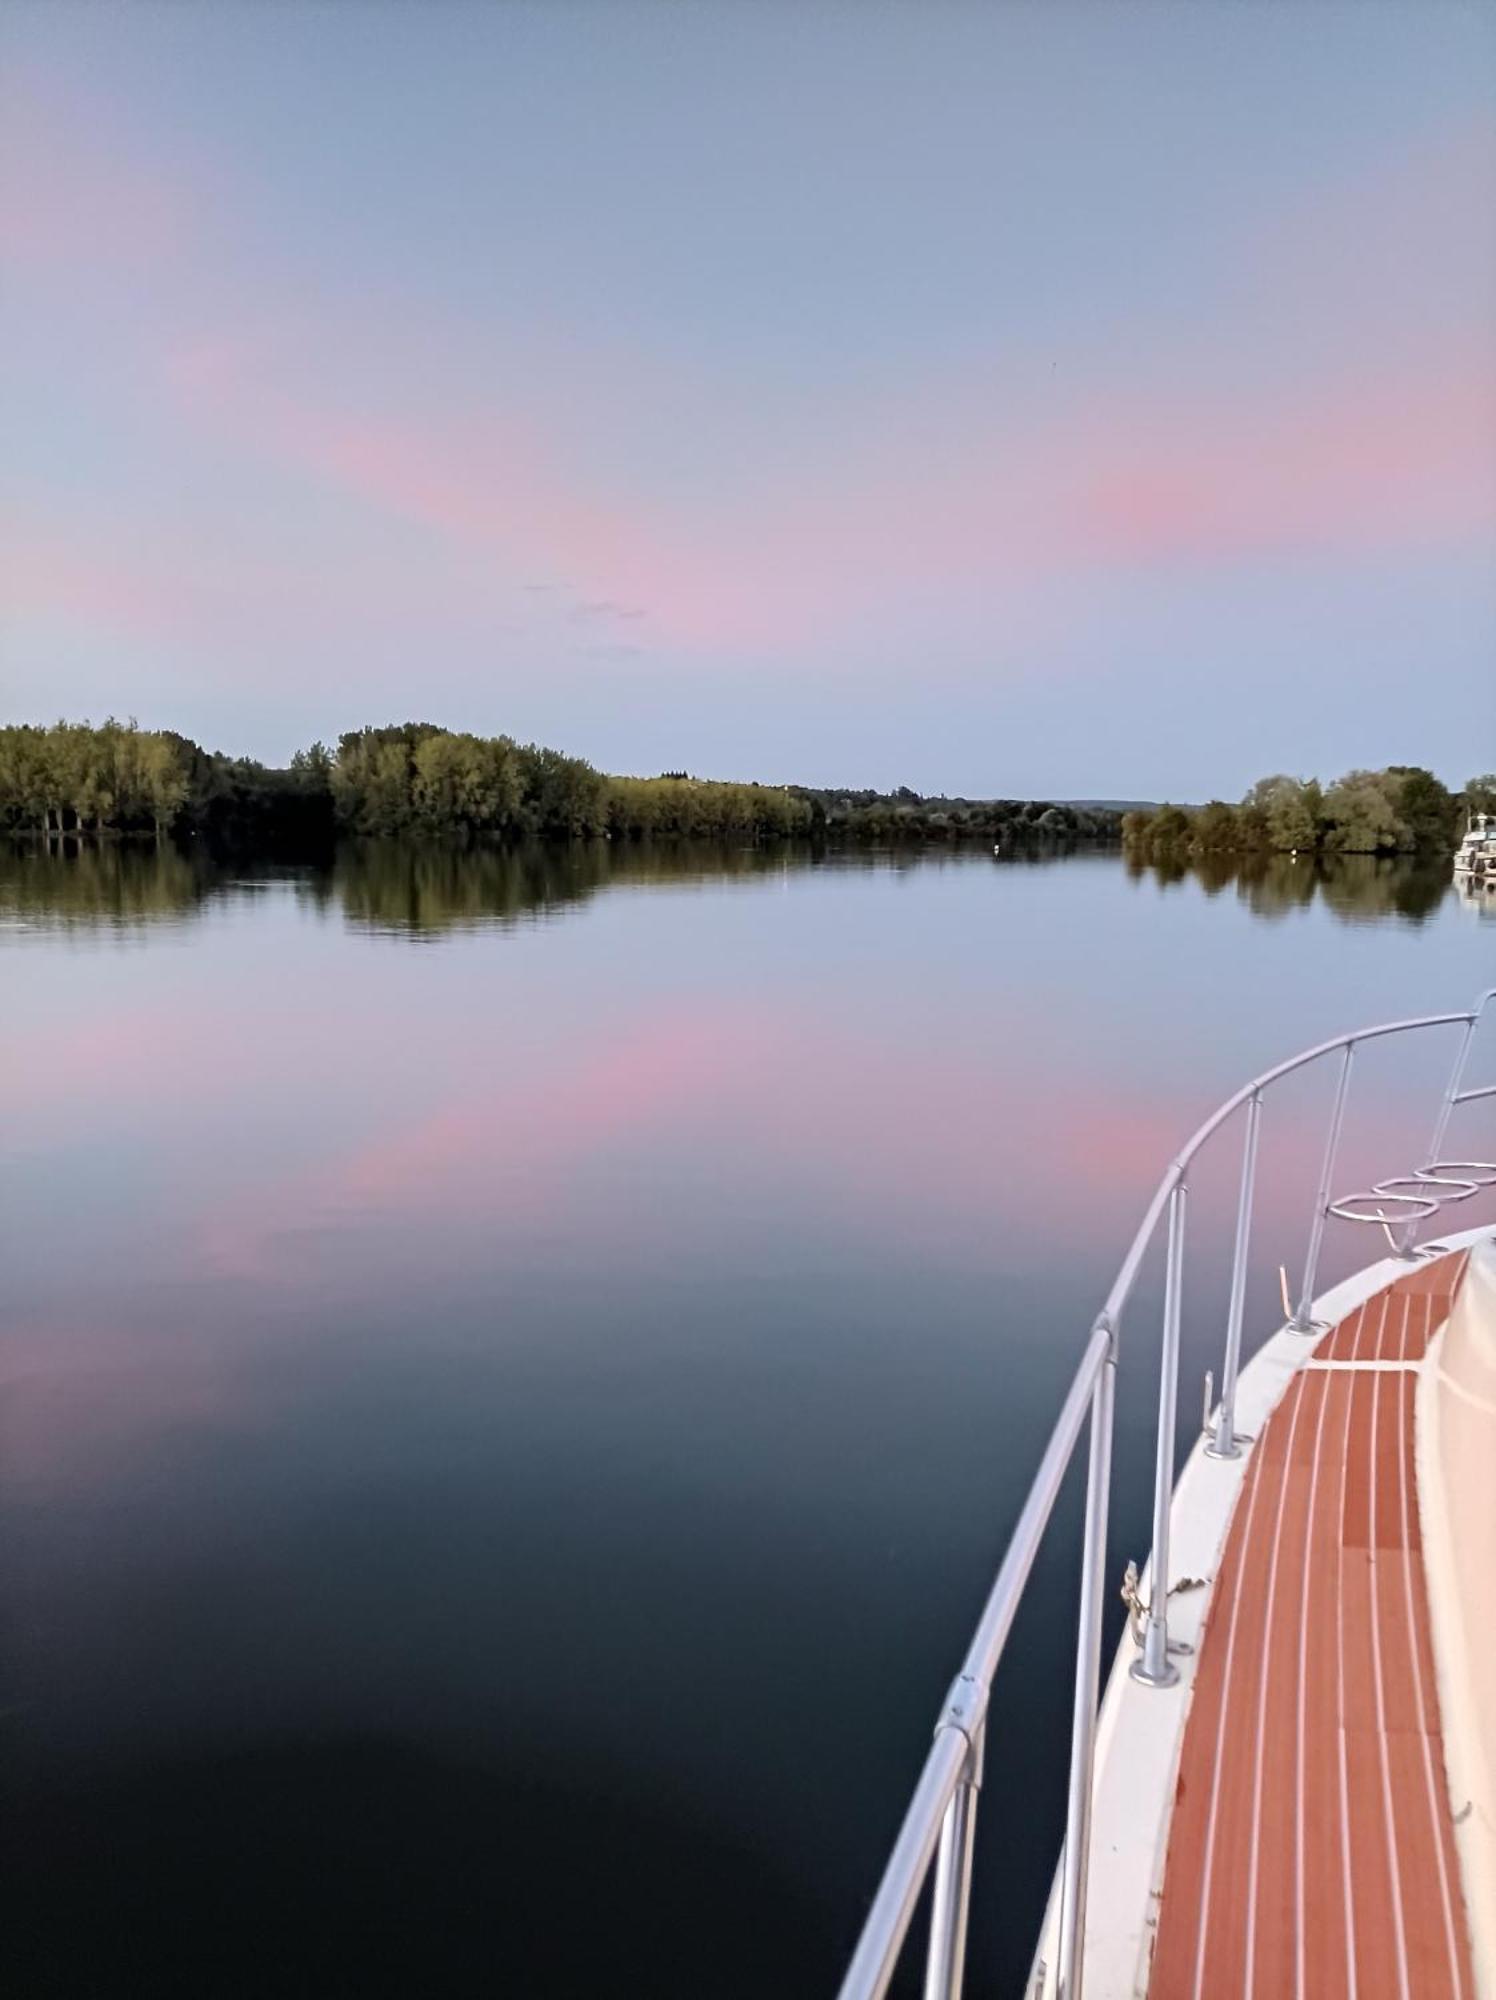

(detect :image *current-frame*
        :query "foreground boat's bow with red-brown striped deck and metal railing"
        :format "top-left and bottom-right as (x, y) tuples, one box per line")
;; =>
(842, 988), (1496, 2000)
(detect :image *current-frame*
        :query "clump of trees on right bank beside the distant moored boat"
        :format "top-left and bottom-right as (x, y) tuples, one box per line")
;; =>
(1122, 764), (1496, 860)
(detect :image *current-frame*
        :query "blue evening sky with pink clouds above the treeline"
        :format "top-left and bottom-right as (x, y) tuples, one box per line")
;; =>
(0, 0), (1496, 798)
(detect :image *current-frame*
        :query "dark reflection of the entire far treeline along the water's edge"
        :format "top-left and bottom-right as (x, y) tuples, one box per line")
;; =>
(0, 840), (1450, 938)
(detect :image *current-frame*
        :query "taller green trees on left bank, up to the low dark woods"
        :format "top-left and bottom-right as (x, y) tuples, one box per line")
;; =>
(0, 720), (812, 844)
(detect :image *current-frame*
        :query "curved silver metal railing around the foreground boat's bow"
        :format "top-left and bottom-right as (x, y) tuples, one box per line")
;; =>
(840, 986), (1496, 2000)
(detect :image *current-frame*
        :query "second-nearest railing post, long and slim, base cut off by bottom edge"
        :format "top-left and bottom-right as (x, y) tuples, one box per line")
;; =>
(1060, 1328), (1116, 2000)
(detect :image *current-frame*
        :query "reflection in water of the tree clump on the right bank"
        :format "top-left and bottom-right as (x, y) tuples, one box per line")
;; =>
(1126, 854), (1450, 924)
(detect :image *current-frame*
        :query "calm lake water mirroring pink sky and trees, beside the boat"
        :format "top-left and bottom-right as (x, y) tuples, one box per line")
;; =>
(0, 850), (1496, 2000)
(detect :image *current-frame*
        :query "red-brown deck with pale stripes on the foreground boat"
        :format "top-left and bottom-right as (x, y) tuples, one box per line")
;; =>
(1148, 1256), (1474, 2000)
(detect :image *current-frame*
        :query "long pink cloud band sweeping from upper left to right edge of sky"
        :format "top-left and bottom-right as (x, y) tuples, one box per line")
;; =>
(155, 320), (1496, 676)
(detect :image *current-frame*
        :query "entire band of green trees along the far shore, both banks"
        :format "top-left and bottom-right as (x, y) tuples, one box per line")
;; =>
(0, 718), (1464, 860)
